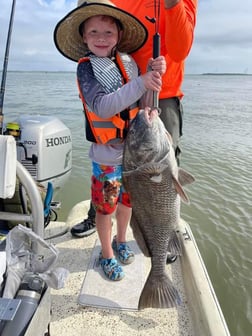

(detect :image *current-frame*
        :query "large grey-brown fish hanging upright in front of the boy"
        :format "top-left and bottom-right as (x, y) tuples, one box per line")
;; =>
(123, 108), (194, 309)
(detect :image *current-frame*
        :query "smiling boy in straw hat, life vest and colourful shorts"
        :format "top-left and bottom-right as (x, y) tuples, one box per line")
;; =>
(55, 0), (166, 281)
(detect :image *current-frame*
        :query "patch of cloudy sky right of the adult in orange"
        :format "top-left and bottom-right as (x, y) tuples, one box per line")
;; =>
(186, 0), (252, 73)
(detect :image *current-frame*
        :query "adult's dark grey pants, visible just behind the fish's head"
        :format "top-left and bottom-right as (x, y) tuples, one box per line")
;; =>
(159, 97), (183, 163)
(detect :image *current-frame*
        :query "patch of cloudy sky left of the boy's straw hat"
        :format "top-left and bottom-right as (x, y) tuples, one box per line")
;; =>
(0, 0), (76, 71)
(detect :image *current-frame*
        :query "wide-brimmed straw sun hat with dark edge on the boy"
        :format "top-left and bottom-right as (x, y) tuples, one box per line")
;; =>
(54, 0), (148, 62)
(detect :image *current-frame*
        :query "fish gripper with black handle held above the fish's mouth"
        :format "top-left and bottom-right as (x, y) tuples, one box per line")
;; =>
(145, 0), (161, 108)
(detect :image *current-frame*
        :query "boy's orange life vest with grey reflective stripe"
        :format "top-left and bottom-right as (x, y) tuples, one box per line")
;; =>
(77, 53), (139, 145)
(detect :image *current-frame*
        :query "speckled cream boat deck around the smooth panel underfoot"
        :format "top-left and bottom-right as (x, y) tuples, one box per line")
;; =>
(45, 202), (195, 336)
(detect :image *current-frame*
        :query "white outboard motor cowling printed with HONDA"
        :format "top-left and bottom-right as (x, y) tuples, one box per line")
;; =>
(13, 115), (72, 192)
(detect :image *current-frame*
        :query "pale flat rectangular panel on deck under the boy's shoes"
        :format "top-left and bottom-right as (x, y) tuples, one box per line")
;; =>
(78, 239), (146, 310)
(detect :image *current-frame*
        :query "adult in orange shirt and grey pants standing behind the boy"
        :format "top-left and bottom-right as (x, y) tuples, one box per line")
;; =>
(71, 0), (198, 256)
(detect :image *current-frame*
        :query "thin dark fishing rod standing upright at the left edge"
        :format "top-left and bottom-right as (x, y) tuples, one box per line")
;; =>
(0, 0), (16, 134)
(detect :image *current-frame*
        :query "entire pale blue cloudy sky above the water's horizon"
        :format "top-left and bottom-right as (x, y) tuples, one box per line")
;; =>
(0, 0), (252, 74)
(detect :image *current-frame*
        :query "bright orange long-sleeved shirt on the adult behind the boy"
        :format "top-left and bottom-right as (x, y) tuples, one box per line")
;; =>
(112, 0), (198, 99)
